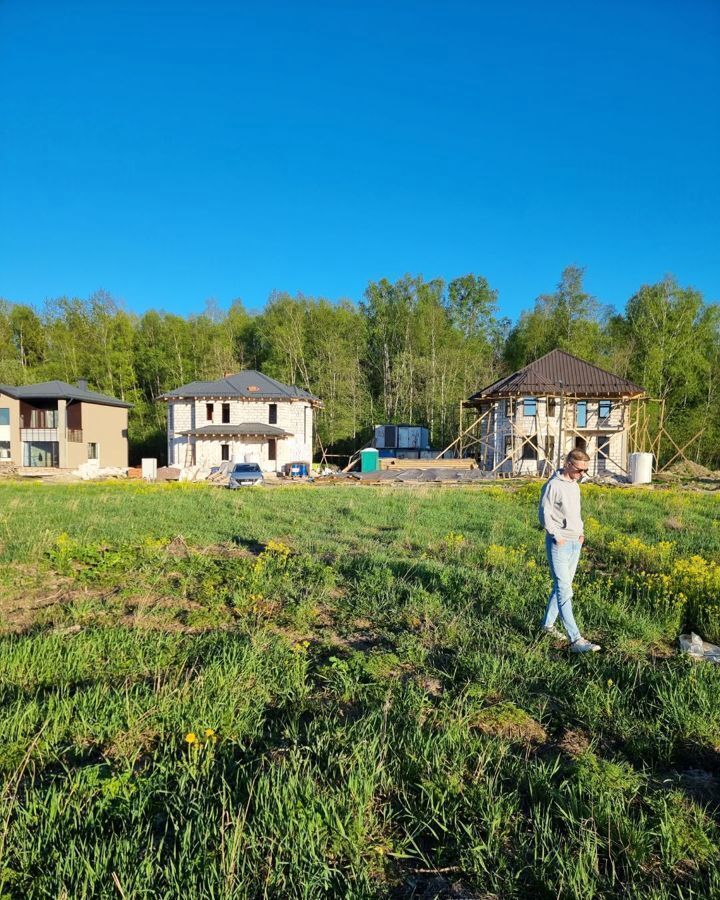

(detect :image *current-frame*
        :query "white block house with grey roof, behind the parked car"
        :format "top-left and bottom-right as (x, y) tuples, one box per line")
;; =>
(163, 369), (322, 472)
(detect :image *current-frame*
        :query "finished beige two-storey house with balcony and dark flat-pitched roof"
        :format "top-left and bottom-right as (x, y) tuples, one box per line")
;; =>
(0, 381), (130, 469)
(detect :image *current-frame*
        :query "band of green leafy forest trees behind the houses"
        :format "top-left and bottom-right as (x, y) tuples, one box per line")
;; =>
(0, 266), (720, 468)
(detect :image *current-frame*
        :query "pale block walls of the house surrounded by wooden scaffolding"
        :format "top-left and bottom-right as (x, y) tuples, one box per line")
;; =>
(481, 397), (627, 475)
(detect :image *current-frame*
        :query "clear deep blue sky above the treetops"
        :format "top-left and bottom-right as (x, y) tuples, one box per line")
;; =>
(0, 0), (720, 318)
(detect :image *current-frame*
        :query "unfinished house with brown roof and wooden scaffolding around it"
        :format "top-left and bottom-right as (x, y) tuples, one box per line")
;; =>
(458, 350), (646, 475)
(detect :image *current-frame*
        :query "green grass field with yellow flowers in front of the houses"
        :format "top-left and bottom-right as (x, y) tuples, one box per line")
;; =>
(0, 483), (720, 900)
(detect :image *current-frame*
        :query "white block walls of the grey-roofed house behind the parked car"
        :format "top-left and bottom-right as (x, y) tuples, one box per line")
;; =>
(167, 398), (313, 472)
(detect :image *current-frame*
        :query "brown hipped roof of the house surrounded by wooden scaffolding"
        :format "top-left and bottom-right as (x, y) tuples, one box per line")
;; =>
(467, 350), (645, 405)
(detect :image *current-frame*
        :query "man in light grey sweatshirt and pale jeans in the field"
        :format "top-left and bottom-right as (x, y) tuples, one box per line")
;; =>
(538, 450), (600, 653)
